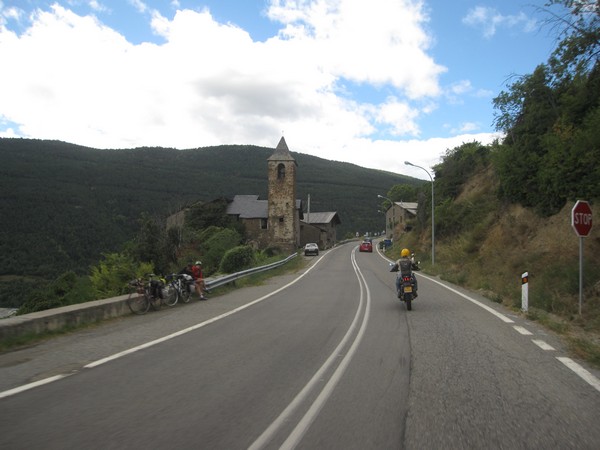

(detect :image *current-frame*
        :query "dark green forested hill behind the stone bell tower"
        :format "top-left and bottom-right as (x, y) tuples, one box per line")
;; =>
(0, 138), (421, 278)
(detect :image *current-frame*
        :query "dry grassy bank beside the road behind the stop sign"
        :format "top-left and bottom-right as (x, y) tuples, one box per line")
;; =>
(398, 166), (600, 367)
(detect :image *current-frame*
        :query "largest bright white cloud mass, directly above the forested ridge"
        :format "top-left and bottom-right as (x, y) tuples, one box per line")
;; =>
(0, 0), (490, 171)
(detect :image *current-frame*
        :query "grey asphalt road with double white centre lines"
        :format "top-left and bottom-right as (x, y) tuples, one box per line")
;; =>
(0, 244), (600, 450)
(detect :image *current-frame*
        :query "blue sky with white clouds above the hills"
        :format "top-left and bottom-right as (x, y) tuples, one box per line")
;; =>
(0, 0), (556, 180)
